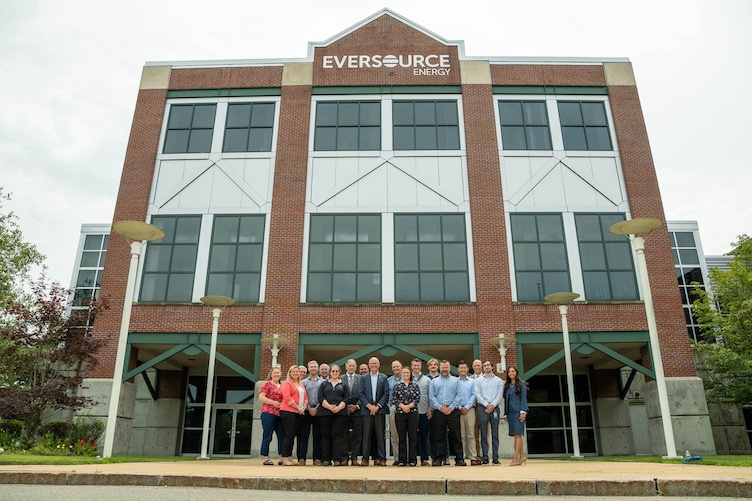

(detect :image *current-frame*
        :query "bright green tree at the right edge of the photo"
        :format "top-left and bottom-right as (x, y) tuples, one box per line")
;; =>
(693, 235), (752, 405)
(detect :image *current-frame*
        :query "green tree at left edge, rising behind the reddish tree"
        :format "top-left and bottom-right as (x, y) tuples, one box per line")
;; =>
(0, 187), (44, 301)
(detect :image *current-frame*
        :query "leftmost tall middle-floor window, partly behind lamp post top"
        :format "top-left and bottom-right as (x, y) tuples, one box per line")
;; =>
(141, 216), (201, 303)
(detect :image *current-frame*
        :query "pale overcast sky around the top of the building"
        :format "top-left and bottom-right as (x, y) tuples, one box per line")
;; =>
(0, 0), (752, 285)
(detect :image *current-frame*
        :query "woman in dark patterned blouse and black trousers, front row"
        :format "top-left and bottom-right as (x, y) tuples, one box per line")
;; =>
(392, 366), (420, 466)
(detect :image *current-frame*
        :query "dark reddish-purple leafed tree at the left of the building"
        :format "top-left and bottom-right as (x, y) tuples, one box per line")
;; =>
(0, 277), (106, 435)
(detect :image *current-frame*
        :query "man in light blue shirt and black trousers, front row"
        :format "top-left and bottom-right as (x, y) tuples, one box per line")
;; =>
(429, 360), (466, 466)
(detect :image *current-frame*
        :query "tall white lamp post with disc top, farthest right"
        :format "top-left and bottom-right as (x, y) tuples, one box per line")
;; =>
(608, 218), (679, 458)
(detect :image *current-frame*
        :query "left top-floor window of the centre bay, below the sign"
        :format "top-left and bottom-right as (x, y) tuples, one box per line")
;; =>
(313, 101), (381, 151)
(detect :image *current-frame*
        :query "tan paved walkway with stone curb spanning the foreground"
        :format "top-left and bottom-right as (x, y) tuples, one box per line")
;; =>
(0, 458), (752, 498)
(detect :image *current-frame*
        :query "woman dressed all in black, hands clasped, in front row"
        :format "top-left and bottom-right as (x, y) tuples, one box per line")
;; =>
(318, 364), (350, 466)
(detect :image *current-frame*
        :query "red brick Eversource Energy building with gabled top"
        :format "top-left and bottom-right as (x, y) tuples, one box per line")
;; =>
(84, 9), (715, 456)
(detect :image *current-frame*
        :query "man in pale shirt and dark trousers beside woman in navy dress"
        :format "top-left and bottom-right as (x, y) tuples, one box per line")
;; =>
(475, 360), (504, 464)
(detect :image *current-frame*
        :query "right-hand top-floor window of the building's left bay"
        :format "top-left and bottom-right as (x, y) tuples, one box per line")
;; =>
(222, 103), (274, 152)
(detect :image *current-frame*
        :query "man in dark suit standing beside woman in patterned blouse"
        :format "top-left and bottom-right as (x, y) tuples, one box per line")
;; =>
(359, 357), (389, 466)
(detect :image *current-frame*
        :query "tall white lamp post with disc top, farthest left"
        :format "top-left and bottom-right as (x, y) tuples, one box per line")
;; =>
(102, 221), (165, 458)
